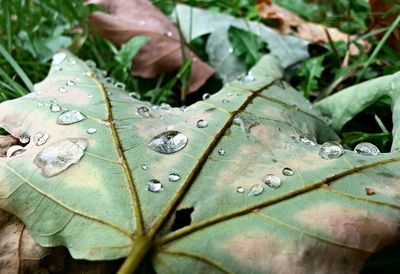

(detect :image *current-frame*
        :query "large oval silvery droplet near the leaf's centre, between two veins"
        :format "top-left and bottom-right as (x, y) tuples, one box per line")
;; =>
(148, 130), (188, 154)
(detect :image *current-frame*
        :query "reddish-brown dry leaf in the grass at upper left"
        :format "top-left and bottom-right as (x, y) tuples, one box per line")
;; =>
(88, 0), (214, 92)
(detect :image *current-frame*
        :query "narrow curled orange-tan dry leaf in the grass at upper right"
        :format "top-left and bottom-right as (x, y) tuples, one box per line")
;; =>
(257, 0), (368, 55)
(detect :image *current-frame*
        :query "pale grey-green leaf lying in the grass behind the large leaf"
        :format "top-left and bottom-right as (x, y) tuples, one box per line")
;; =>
(171, 4), (308, 82)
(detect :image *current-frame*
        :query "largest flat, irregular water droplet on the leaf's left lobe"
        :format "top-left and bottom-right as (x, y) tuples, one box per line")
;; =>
(34, 138), (89, 177)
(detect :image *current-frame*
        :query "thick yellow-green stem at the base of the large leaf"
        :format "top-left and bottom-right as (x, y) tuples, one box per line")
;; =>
(117, 235), (152, 274)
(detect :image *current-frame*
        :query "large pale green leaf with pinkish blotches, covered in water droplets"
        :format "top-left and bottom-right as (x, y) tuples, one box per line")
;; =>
(0, 52), (400, 273)
